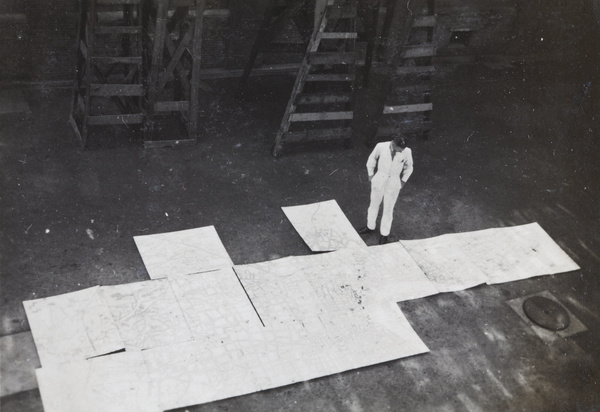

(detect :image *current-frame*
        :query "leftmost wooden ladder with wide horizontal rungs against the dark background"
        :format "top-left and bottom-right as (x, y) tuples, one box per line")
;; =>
(69, 0), (145, 148)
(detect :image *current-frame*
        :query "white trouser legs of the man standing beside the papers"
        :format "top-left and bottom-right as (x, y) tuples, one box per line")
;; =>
(367, 174), (401, 236)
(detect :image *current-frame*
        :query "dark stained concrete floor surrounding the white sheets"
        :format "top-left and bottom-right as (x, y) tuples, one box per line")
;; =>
(0, 50), (600, 412)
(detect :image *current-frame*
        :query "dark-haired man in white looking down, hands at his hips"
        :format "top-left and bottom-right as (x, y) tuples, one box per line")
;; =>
(358, 136), (413, 244)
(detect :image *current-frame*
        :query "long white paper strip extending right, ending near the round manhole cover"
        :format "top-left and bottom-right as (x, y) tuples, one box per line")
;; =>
(401, 223), (579, 286)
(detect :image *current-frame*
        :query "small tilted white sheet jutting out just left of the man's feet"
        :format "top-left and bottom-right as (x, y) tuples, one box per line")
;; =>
(282, 200), (366, 252)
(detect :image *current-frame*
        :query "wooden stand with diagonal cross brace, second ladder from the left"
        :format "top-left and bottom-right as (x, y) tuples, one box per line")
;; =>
(144, 0), (229, 148)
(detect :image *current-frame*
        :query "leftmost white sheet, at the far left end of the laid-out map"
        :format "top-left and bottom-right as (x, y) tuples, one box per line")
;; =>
(23, 286), (124, 367)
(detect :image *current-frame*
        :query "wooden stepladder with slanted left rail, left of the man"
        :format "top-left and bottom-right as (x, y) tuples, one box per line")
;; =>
(272, 0), (357, 157)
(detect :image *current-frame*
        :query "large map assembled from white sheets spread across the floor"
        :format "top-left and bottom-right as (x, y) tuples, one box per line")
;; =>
(24, 216), (578, 412)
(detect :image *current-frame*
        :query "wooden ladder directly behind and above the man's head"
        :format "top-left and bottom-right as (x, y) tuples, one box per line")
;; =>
(366, 1), (436, 146)
